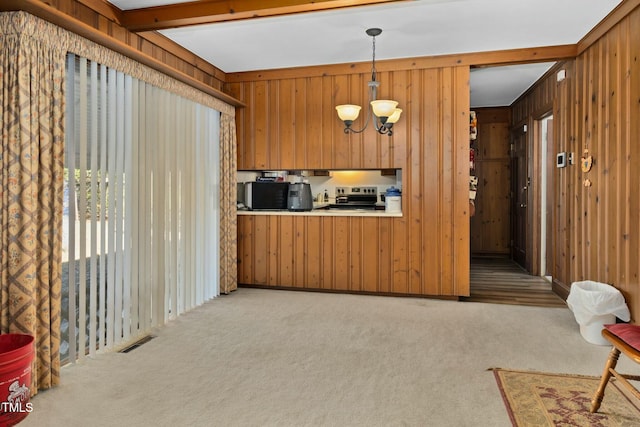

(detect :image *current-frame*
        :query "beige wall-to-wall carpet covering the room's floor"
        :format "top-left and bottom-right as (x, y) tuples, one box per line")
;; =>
(21, 288), (625, 427)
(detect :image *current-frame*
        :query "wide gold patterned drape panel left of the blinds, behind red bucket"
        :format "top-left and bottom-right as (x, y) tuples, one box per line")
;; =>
(0, 14), (66, 394)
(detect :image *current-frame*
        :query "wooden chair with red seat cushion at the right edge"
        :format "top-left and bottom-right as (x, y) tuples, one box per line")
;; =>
(591, 323), (640, 412)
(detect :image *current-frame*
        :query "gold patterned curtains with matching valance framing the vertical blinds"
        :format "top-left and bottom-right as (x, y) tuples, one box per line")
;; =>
(0, 12), (237, 394)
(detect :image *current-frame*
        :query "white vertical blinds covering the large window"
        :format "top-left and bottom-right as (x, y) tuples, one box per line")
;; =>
(61, 54), (220, 362)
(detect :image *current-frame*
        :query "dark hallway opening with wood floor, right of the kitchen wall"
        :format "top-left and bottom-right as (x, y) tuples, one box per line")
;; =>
(463, 107), (566, 307)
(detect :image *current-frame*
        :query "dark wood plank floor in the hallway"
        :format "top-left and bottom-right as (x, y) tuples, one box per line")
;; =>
(462, 257), (567, 307)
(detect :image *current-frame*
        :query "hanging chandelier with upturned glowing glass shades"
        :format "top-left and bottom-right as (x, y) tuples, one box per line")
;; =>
(336, 28), (402, 136)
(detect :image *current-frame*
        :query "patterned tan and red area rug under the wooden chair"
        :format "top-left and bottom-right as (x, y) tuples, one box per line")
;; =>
(493, 369), (640, 427)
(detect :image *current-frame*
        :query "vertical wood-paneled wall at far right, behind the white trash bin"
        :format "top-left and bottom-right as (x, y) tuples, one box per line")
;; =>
(513, 8), (640, 321)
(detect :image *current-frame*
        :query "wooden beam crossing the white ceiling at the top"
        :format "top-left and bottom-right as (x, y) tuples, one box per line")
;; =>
(121, 0), (410, 32)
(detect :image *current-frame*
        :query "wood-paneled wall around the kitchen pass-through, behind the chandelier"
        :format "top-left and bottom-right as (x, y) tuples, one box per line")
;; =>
(226, 66), (469, 296)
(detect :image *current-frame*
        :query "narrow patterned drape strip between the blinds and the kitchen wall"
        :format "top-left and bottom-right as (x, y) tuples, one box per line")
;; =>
(220, 113), (238, 294)
